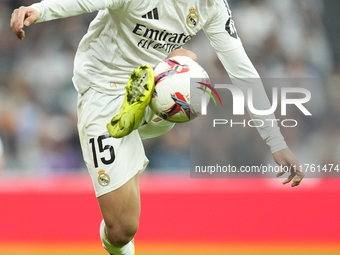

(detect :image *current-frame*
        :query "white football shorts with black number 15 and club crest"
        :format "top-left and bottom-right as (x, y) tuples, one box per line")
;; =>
(78, 88), (149, 197)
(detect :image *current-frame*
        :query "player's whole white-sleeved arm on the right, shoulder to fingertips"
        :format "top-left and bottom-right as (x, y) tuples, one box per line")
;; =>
(204, 0), (304, 187)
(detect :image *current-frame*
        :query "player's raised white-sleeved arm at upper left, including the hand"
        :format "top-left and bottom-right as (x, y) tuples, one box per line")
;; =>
(11, 0), (129, 40)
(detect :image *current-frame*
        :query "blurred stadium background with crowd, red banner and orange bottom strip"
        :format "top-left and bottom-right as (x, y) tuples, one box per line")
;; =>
(0, 0), (340, 254)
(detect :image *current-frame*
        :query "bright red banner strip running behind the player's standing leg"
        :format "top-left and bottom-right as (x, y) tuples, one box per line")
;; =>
(0, 174), (340, 242)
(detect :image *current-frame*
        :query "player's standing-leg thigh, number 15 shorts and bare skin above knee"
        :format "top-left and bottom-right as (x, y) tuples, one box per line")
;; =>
(78, 87), (148, 219)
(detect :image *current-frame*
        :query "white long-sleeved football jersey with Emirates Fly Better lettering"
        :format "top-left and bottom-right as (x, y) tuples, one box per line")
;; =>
(31, 0), (287, 152)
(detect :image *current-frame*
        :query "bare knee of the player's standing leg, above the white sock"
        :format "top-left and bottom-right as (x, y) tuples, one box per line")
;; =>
(106, 222), (138, 247)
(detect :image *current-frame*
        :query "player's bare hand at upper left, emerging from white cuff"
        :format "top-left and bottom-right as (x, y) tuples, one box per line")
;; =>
(11, 6), (40, 40)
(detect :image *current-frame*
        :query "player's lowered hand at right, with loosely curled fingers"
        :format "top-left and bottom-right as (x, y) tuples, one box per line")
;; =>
(273, 148), (305, 187)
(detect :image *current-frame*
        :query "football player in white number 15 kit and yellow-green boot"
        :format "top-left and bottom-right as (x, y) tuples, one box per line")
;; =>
(11, 0), (303, 255)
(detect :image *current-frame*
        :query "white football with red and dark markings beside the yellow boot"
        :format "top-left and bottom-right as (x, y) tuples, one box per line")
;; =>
(150, 56), (210, 122)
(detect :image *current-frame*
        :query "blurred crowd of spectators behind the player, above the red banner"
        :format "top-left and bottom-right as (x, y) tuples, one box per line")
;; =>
(0, 0), (340, 174)
